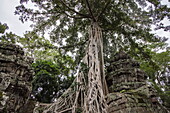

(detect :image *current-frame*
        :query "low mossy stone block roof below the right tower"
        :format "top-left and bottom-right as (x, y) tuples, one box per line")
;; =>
(107, 92), (168, 113)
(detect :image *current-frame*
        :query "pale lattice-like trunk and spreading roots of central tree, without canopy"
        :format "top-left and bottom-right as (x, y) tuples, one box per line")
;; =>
(35, 23), (108, 113)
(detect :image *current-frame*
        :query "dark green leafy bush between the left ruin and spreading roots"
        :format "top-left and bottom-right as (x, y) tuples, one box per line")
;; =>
(30, 44), (75, 103)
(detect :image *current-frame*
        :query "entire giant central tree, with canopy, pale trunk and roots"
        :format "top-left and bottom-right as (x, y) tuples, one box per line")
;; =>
(15, 0), (169, 113)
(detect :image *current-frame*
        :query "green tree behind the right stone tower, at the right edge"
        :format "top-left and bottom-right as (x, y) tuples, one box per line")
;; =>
(125, 36), (170, 108)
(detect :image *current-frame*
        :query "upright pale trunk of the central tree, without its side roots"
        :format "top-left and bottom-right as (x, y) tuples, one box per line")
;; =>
(83, 23), (107, 113)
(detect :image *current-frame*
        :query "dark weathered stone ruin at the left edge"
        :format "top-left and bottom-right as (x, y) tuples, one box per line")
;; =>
(0, 43), (33, 113)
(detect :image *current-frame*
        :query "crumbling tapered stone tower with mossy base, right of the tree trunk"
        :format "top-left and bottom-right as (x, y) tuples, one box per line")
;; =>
(106, 52), (168, 113)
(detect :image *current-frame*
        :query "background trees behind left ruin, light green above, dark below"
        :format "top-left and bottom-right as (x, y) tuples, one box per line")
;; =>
(0, 23), (75, 103)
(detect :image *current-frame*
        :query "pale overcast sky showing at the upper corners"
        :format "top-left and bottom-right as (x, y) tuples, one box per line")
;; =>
(0, 0), (170, 44)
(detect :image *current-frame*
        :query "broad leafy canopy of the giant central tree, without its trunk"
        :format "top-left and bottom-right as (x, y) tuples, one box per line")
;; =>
(15, 0), (169, 62)
